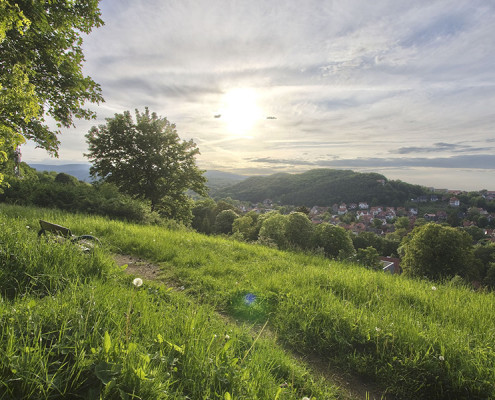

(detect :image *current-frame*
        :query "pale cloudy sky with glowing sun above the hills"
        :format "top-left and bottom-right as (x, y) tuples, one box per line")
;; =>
(22, 0), (495, 190)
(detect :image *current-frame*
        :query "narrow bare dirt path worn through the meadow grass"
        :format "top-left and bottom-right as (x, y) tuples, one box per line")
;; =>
(114, 254), (393, 400)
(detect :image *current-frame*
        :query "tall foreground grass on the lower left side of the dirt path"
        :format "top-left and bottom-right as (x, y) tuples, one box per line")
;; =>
(0, 207), (337, 399)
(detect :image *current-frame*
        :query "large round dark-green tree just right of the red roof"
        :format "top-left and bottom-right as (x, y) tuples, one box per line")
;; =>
(402, 223), (475, 279)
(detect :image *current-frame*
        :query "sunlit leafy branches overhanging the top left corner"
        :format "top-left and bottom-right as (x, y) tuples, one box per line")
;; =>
(0, 0), (103, 179)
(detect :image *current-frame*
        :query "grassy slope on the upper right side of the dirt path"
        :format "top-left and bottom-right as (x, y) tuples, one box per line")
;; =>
(3, 208), (495, 399)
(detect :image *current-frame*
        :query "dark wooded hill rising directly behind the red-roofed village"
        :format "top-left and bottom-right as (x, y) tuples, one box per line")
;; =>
(212, 169), (425, 207)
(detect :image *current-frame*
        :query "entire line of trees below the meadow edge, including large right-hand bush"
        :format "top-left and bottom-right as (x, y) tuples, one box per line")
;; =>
(192, 199), (495, 289)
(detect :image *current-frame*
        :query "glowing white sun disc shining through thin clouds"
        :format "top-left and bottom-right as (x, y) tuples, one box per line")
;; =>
(221, 88), (262, 136)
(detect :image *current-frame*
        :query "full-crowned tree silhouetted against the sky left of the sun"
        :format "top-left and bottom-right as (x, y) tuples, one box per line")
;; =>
(86, 108), (206, 220)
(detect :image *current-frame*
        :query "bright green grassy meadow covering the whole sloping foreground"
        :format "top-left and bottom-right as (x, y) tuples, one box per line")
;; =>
(0, 205), (495, 399)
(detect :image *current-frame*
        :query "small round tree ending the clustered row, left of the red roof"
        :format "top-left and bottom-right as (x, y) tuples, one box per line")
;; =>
(314, 222), (354, 259)
